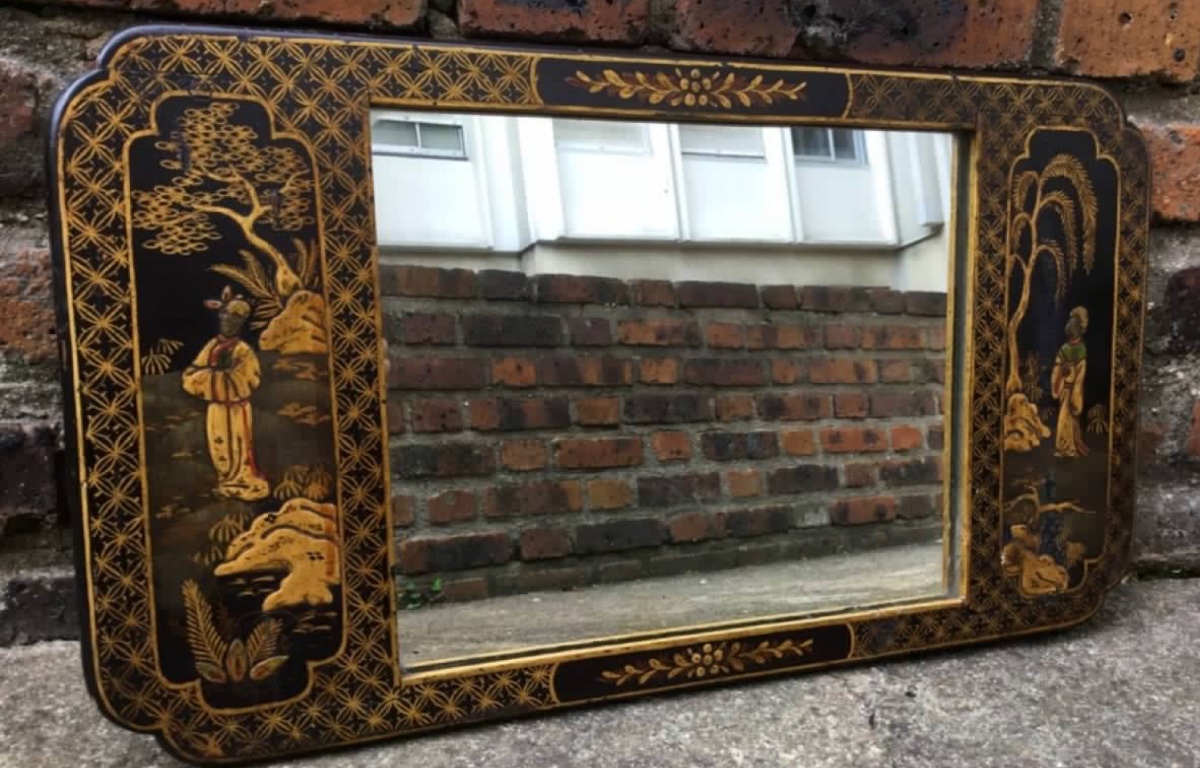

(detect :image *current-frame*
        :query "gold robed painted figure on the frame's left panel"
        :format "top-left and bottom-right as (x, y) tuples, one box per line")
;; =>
(184, 287), (270, 502)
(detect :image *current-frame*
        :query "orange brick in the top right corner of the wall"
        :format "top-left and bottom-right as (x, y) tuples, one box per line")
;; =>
(1054, 0), (1200, 83)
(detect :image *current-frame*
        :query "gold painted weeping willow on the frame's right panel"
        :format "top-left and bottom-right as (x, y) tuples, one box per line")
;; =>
(1004, 155), (1098, 452)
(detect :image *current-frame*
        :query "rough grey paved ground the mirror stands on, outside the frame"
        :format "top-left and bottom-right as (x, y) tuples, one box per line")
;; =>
(0, 580), (1200, 768)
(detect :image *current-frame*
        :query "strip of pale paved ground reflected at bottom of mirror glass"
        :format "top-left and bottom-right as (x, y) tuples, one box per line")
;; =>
(400, 541), (946, 668)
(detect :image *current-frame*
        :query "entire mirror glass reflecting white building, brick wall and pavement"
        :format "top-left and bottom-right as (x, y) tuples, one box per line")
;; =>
(371, 110), (958, 668)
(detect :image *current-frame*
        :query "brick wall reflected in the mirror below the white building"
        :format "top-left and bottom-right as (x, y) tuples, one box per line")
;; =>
(383, 266), (946, 596)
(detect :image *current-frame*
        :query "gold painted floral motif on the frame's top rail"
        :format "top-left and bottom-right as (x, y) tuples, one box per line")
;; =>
(568, 68), (808, 109)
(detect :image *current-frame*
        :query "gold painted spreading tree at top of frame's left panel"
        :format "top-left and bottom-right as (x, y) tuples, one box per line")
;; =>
(133, 102), (314, 300)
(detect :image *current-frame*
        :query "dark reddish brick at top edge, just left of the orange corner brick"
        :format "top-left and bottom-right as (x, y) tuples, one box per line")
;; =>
(830, 0), (1038, 68)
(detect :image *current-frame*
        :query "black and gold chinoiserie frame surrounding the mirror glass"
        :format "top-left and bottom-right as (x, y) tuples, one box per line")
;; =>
(49, 22), (1148, 763)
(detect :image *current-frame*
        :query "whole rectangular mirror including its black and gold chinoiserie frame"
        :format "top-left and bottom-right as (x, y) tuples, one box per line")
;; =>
(49, 28), (1148, 764)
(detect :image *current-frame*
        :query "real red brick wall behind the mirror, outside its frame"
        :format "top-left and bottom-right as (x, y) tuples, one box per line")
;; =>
(0, 0), (1200, 643)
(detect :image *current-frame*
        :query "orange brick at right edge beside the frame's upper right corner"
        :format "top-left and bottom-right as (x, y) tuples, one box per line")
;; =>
(1138, 124), (1200, 222)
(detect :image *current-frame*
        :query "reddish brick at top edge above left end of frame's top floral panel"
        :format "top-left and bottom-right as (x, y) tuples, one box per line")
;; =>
(458, 0), (650, 44)
